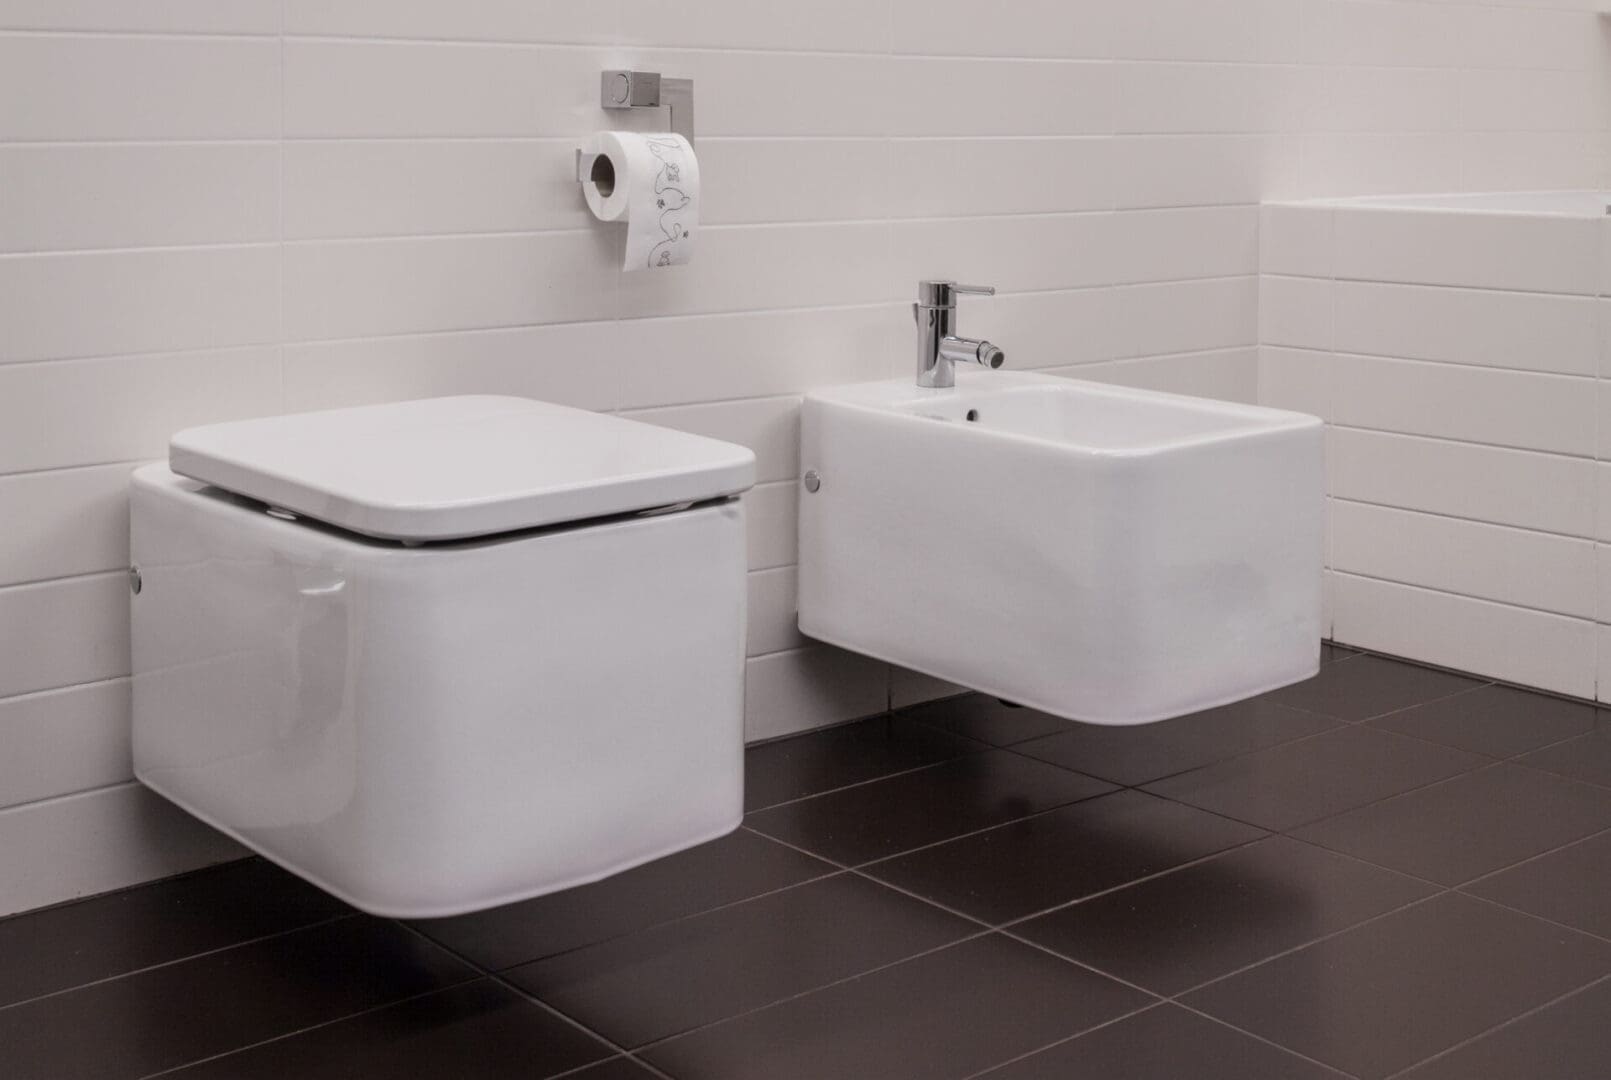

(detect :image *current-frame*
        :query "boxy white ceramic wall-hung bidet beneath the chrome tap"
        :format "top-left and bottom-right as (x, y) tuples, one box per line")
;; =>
(799, 283), (1324, 724)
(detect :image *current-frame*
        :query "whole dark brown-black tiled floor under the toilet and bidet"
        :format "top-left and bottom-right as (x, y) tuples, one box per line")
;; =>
(9, 648), (1611, 1080)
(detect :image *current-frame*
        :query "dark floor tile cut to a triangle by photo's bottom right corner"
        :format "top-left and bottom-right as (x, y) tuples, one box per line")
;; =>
(1403, 982), (1611, 1080)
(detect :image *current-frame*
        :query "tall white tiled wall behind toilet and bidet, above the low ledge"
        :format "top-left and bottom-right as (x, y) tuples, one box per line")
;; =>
(0, 0), (1611, 912)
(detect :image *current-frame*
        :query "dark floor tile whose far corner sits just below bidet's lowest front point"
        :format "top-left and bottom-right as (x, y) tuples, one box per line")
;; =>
(865, 791), (1263, 924)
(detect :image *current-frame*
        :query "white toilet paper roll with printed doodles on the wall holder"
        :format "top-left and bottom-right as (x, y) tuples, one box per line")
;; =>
(582, 131), (699, 271)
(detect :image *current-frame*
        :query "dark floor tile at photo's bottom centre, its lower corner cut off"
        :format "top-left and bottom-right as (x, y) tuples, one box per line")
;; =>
(641, 935), (1149, 1080)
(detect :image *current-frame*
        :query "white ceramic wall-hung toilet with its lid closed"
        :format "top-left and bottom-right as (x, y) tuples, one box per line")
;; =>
(130, 397), (754, 917)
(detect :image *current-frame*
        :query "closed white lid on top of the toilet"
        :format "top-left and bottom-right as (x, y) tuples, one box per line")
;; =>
(168, 397), (756, 540)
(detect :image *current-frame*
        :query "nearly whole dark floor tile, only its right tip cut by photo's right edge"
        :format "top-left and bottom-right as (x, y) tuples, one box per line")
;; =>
(1294, 764), (1611, 885)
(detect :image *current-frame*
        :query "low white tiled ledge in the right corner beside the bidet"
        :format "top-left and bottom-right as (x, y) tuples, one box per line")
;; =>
(1260, 203), (1611, 701)
